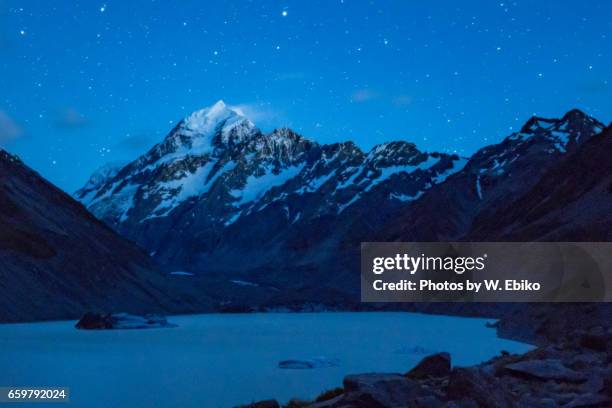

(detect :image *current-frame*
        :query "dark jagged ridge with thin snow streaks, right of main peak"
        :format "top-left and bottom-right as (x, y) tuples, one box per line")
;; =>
(380, 110), (604, 241)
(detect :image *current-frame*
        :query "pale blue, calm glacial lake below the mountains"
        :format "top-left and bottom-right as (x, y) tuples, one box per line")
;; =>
(0, 312), (531, 408)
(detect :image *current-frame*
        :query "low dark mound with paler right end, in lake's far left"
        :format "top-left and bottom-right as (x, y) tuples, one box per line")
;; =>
(75, 312), (176, 330)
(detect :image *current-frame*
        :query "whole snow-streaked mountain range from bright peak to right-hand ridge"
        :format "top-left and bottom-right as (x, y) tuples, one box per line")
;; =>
(74, 102), (603, 305)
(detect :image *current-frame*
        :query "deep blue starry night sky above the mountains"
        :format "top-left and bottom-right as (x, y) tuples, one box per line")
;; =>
(0, 0), (612, 192)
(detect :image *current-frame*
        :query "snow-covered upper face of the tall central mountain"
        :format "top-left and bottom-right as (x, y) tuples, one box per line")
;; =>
(76, 101), (460, 233)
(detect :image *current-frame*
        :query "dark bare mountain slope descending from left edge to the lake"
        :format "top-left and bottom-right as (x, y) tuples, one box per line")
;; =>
(0, 149), (212, 322)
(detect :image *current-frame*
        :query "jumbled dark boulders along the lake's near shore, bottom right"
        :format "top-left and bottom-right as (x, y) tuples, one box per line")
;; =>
(262, 334), (612, 408)
